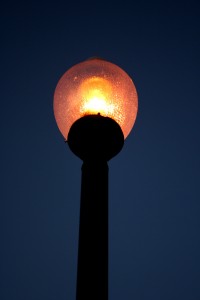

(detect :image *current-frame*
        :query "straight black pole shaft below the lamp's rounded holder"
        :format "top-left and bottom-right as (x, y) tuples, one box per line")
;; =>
(76, 160), (108, 300)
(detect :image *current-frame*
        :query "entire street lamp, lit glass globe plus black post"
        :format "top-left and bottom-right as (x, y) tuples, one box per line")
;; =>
(54, 58), (138, 300)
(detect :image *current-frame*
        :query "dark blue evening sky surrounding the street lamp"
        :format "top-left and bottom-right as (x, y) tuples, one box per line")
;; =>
(0, 0), (200, 300)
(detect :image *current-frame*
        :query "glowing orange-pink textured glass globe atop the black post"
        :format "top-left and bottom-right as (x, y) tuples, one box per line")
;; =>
(54, 58), (138, 140)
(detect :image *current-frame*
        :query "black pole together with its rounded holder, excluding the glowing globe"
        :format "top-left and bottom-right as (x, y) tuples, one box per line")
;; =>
(68, 115), (124, 300)
